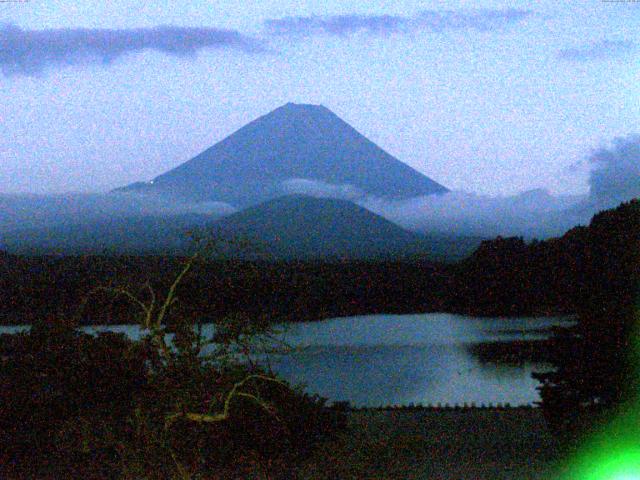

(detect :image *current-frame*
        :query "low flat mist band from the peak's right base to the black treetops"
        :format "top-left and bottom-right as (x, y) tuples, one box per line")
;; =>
(280, 178), (593, 238)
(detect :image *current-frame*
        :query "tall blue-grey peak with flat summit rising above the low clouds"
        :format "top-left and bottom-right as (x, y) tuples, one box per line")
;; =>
(117, 103), (447, 207)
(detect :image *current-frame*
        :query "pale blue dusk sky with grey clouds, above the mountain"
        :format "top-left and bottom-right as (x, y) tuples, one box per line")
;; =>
(0, 0), (640, 195)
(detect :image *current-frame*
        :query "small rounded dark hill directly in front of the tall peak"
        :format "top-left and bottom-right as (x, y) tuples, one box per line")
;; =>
(205, 195), (430, 259)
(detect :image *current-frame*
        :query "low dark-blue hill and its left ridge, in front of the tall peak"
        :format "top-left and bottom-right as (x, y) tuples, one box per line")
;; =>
(0, 195), (480, 261)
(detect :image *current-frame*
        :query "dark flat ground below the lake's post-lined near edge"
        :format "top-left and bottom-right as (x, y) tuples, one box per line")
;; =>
(291, 409), (566, 480)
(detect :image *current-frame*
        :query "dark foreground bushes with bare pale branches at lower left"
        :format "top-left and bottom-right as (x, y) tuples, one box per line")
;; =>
(0, 263), (342, 479)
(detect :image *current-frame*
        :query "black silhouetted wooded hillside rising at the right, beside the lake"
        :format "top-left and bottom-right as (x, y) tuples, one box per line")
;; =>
(451, 199), (640, 444)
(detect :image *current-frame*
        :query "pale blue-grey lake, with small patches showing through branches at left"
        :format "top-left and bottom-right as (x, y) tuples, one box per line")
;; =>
(0, 313), (571, 407)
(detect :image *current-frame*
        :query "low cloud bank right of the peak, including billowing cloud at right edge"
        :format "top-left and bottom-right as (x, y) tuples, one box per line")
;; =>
(281, 134), (640, 238)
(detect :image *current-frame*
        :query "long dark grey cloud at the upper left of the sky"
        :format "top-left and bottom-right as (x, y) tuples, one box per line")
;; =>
(0, 25), (266, 76)
